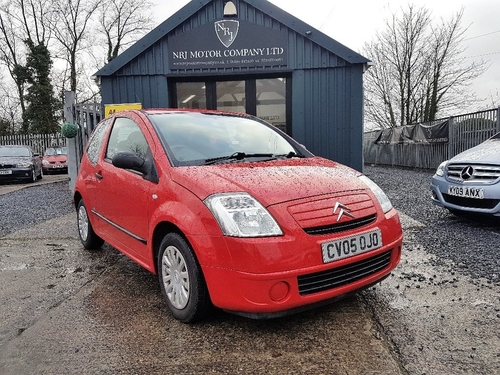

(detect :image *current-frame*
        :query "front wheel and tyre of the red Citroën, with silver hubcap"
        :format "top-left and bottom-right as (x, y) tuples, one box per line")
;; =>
(158, 233), (212, 323)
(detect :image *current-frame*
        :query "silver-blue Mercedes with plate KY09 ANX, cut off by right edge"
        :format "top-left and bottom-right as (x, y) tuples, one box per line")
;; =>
(431, 133), (500, 217)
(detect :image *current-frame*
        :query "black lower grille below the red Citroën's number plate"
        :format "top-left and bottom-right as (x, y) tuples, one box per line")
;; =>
(297, 250), (392, 296)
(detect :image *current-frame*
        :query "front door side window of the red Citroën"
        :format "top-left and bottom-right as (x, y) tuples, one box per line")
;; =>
(106, 117), (148, 160)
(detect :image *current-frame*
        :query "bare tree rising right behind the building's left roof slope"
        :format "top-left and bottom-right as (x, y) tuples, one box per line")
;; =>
(99, 0), (153, 62)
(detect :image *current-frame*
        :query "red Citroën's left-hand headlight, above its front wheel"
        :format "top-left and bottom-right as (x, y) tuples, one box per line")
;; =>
(204, 193), (283, 237)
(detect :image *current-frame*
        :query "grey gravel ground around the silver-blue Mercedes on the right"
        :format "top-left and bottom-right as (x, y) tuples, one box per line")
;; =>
(364, 166), (500, 284)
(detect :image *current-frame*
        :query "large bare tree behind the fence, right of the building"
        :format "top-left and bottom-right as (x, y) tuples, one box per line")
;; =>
(364, 5), (485, 128)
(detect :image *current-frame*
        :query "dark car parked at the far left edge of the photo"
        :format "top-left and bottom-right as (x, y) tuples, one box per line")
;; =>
(0, 145), (43, 182)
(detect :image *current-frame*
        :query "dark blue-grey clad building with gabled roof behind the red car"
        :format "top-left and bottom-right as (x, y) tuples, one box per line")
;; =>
(95, 0), (369, 171)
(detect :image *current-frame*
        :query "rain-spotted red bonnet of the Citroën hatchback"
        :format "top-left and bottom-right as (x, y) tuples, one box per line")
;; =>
(172, 157), (366, 206)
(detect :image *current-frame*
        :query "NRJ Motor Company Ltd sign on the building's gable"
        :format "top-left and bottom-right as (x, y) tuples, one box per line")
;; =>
(168, 19), (288, 70)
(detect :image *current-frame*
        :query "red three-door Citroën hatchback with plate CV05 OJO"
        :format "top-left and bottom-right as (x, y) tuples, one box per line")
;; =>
(74, 109), (403, 322)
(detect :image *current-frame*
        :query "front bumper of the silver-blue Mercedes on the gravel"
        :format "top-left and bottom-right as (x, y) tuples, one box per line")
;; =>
(430, 175), (500, 216)
